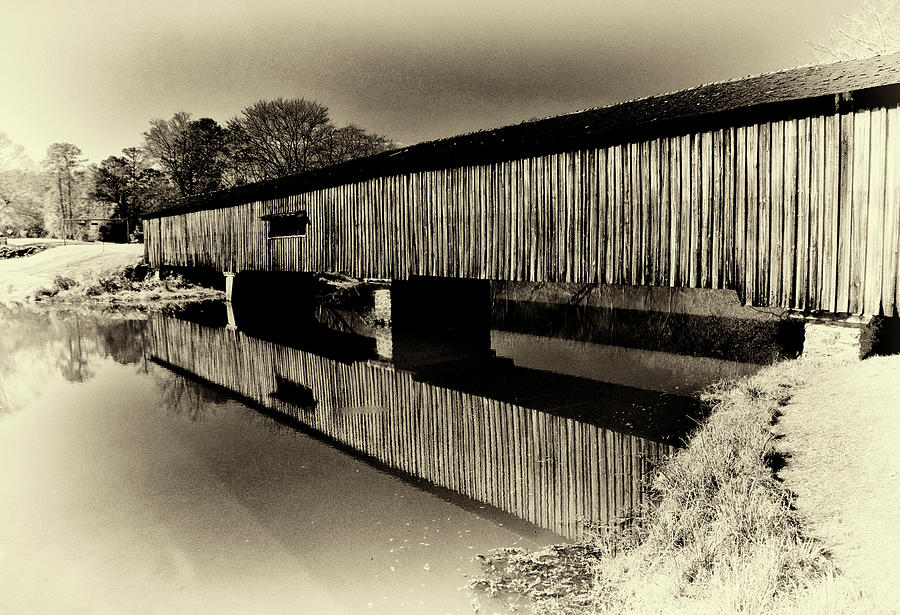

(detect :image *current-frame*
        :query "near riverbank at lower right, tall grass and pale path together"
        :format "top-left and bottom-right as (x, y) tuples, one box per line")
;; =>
(473, 356), (900, 613)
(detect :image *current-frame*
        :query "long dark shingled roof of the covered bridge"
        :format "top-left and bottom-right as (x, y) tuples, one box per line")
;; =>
(146, 53), (900, 218)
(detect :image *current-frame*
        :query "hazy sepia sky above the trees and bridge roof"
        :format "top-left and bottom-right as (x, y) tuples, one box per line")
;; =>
(0, 0), (876, 162)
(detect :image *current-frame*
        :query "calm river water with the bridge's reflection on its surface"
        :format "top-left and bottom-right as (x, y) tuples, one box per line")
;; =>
(0, 306), (772, 613)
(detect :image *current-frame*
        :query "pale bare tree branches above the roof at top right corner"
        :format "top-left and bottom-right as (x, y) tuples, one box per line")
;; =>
(807, 0), (900, 60)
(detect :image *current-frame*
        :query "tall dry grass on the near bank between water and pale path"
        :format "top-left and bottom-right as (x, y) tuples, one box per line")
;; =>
(472, 359), (877, 613)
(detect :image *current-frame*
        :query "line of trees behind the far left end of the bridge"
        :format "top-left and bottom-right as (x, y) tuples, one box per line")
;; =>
(0, 98), (394, 240)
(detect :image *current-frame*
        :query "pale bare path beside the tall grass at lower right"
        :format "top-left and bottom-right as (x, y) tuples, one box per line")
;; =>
(778, 355), (900, 612)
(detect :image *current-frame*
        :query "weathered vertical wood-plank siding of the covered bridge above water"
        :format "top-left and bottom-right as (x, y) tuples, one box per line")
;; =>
(145, 107), (900, 315)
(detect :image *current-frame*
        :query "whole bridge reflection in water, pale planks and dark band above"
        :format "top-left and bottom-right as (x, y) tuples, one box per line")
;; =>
(145, 308), (712, 539)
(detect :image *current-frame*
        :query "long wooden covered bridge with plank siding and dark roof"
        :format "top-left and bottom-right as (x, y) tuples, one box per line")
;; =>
(144, 54), (900, 316)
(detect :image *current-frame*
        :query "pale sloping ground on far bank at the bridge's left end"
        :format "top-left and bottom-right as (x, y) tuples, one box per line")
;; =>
(0, 243), (144, 303)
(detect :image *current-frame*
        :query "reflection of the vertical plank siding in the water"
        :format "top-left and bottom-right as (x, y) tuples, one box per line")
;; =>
(148, 318), (673, 538)
